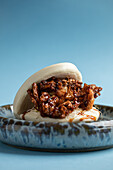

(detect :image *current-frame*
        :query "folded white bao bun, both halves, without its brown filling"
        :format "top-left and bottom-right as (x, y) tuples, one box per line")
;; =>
(13, 63), (100, 122)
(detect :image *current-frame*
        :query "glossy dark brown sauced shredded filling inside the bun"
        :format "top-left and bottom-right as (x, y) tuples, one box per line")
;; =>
(23, 77), (102, 119)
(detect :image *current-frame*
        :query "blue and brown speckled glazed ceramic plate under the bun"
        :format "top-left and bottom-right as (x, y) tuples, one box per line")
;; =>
(0, 105), (113, 152)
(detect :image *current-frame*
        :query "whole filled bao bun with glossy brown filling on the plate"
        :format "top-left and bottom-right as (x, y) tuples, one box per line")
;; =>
(13, 63), (102, 122)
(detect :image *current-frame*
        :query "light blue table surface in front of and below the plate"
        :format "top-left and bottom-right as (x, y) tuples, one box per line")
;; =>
(0, 143), (113, 170)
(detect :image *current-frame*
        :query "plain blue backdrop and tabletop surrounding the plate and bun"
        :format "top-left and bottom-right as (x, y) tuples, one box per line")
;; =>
(0, 0), (113, 170)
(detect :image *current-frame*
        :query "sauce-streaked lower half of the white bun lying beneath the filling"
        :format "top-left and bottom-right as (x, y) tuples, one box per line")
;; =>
(20, 107), (100, 123)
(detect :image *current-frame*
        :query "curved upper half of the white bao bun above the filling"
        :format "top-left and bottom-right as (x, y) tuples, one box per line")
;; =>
(13, 63), (82, 118)
